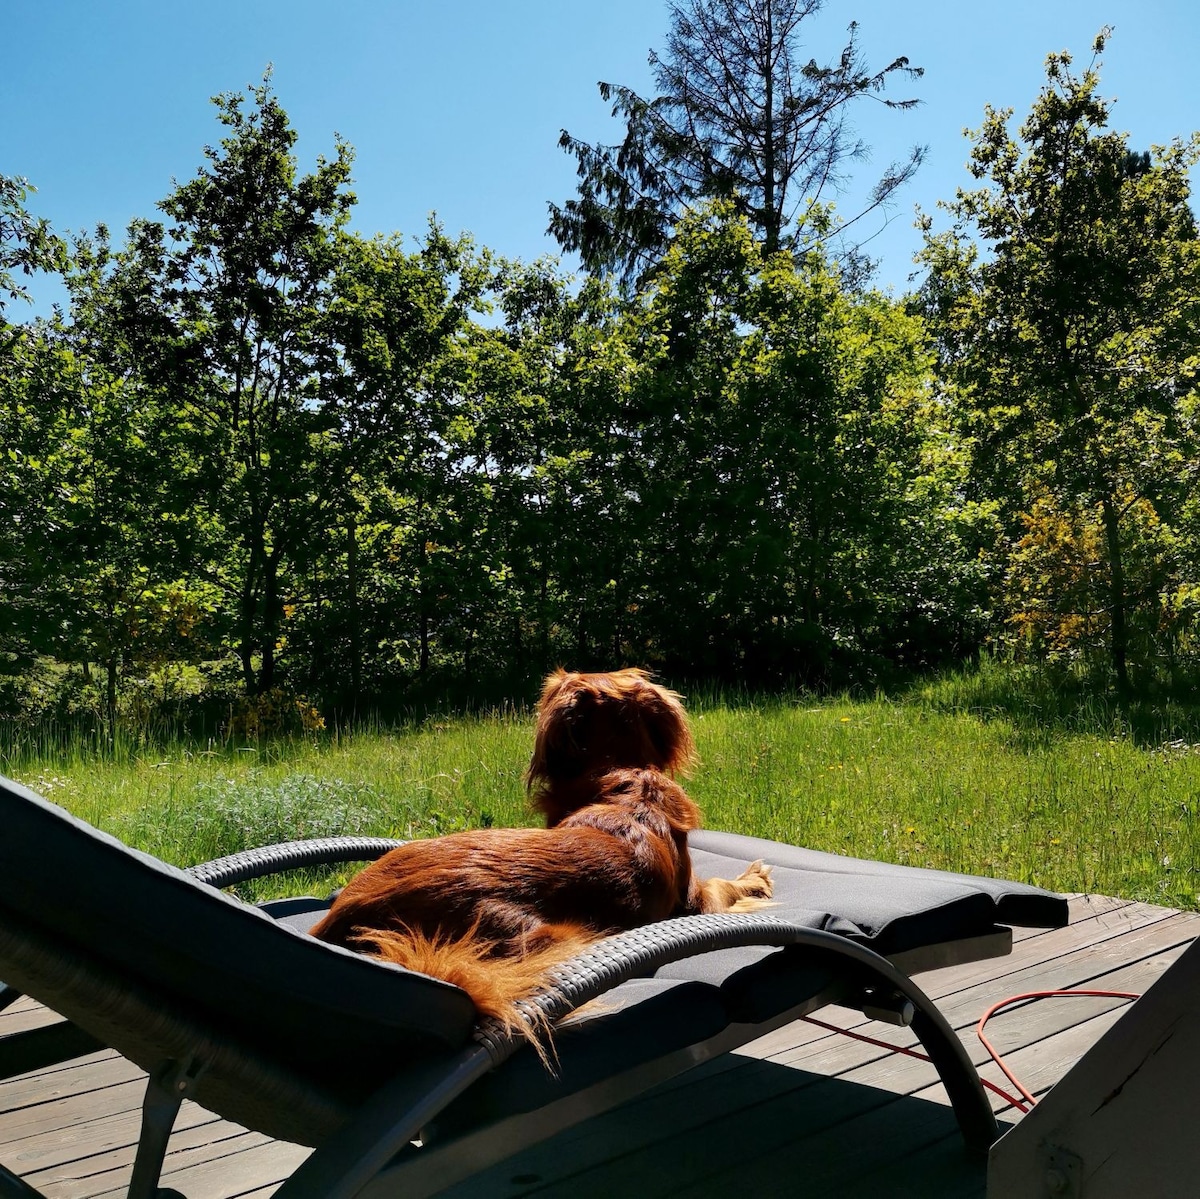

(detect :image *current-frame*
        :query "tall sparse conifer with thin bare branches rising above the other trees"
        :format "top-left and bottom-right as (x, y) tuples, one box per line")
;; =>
(547, 0), (924, 283)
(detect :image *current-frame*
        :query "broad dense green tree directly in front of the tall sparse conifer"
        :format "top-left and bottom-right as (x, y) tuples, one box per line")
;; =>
(571, 202), (947, 681)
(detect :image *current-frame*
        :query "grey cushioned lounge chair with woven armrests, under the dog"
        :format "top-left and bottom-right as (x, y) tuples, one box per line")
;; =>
(0, 780), (1067, 1199)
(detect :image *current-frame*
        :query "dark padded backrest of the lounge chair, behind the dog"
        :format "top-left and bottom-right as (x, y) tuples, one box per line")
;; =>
(0, 779), (475, 1091)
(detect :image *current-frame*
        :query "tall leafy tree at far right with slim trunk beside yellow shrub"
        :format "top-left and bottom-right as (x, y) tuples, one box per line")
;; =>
(923, 30), (1200, 694)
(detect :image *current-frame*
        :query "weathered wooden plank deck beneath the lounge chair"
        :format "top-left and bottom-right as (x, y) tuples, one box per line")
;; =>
(0, 895), (1200, 1199)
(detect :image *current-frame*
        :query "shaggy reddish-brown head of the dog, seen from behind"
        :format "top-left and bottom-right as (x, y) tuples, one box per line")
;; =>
(526, 670), (696, 796)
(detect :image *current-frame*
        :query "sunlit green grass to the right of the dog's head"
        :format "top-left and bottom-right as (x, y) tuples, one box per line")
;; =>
(691, 700), (1200, 906)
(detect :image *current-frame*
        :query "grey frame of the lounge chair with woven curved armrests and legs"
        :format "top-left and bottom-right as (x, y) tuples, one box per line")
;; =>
(0, 838), (1012, 1199)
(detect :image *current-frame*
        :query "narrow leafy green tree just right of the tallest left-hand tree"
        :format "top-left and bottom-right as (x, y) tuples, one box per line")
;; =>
(308, 224), (494, 702)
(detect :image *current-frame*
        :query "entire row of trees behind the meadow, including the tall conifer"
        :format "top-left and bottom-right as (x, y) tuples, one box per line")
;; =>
(7, 30), (1200, 750)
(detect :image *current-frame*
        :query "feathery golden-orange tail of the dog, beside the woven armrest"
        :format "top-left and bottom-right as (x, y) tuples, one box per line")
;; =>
(352, 924), (602, 1067)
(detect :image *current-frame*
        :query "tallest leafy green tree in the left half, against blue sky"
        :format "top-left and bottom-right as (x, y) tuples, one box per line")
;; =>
(115, 80), (354, 695)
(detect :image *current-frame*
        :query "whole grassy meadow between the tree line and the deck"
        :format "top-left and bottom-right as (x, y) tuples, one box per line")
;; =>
(7, 669), (1200, 907)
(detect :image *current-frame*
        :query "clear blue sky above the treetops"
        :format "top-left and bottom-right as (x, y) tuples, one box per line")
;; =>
(0, 0), (1200, 316)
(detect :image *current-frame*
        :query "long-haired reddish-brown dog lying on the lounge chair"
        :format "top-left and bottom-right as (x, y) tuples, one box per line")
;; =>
(312, 670), (772, 1037)
